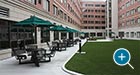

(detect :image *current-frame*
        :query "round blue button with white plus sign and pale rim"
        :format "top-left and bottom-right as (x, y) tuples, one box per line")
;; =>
(113, 48), (131, 66)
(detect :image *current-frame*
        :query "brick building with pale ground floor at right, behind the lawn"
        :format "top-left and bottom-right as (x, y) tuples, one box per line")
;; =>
(118, 0), (140, 40)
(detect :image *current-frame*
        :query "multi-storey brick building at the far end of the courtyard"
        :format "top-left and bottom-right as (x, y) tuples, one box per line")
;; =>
(81, 1), (106, 38)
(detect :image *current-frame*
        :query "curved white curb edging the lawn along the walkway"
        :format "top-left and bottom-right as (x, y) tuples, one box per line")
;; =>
(62, 39), (86, 75)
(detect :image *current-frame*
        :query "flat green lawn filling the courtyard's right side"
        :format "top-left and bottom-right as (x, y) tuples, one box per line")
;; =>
(66, 40), (140, 75)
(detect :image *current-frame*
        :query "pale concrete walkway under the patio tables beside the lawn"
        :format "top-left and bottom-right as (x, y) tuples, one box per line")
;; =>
(0, 40), (86, 75)
